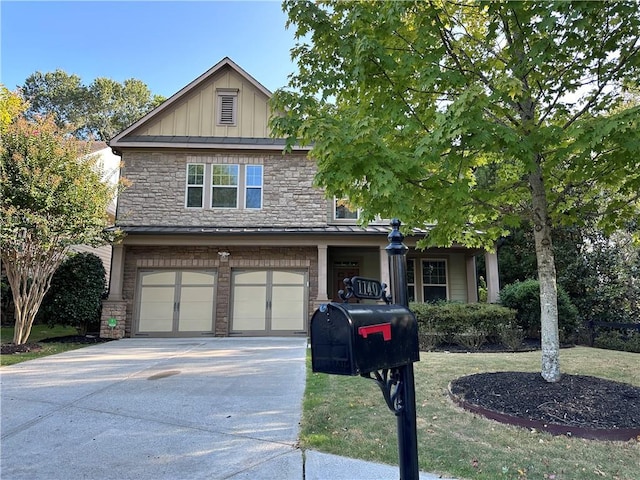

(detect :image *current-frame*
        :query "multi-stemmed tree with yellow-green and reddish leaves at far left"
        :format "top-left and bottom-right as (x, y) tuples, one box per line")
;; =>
(0, 112), (116, 344)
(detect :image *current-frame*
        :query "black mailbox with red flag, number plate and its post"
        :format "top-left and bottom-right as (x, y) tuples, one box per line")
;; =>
(310, 219), (420, 480)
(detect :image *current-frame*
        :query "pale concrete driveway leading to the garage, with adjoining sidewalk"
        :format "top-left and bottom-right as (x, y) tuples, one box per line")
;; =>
(0, 337), (450, 480)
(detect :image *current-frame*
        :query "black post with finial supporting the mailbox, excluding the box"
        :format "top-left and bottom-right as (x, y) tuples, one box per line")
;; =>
(386, 218), (420, 480)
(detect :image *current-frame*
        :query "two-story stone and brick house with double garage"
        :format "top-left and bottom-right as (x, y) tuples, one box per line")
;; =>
(101, 58), (497, 338)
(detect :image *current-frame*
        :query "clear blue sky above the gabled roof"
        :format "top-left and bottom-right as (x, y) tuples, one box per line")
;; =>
(0, 0), (295, 97)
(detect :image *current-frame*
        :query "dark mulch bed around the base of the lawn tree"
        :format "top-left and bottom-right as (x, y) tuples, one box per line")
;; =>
(449, 372), (640, 440)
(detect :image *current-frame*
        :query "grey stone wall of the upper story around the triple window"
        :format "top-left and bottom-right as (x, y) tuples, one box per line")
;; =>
(118, 150), (327, 227)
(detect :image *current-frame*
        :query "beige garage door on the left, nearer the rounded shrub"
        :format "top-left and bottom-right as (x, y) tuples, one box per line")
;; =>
(134, 270), (216, 336)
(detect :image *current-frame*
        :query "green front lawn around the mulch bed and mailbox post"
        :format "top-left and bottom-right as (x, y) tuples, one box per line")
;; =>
(301, 347), (640, 480)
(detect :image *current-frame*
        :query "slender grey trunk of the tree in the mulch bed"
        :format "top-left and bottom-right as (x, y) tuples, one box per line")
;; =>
(529, 162), (560, 382)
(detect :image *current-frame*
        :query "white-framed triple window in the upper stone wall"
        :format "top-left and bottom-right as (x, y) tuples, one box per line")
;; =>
(185, 163), (264, 210)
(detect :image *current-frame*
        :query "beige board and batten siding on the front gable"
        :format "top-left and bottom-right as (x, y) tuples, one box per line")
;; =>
(135, 68), (269, 138)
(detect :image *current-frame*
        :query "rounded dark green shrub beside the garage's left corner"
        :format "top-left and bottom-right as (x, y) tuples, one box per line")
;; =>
(37, 253), (106, 335)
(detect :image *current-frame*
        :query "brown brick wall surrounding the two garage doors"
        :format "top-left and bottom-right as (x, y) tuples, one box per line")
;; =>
(122, 245), (318, 337)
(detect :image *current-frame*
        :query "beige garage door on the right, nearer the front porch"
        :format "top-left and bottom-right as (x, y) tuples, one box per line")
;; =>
(231, 270), (308, 335)
